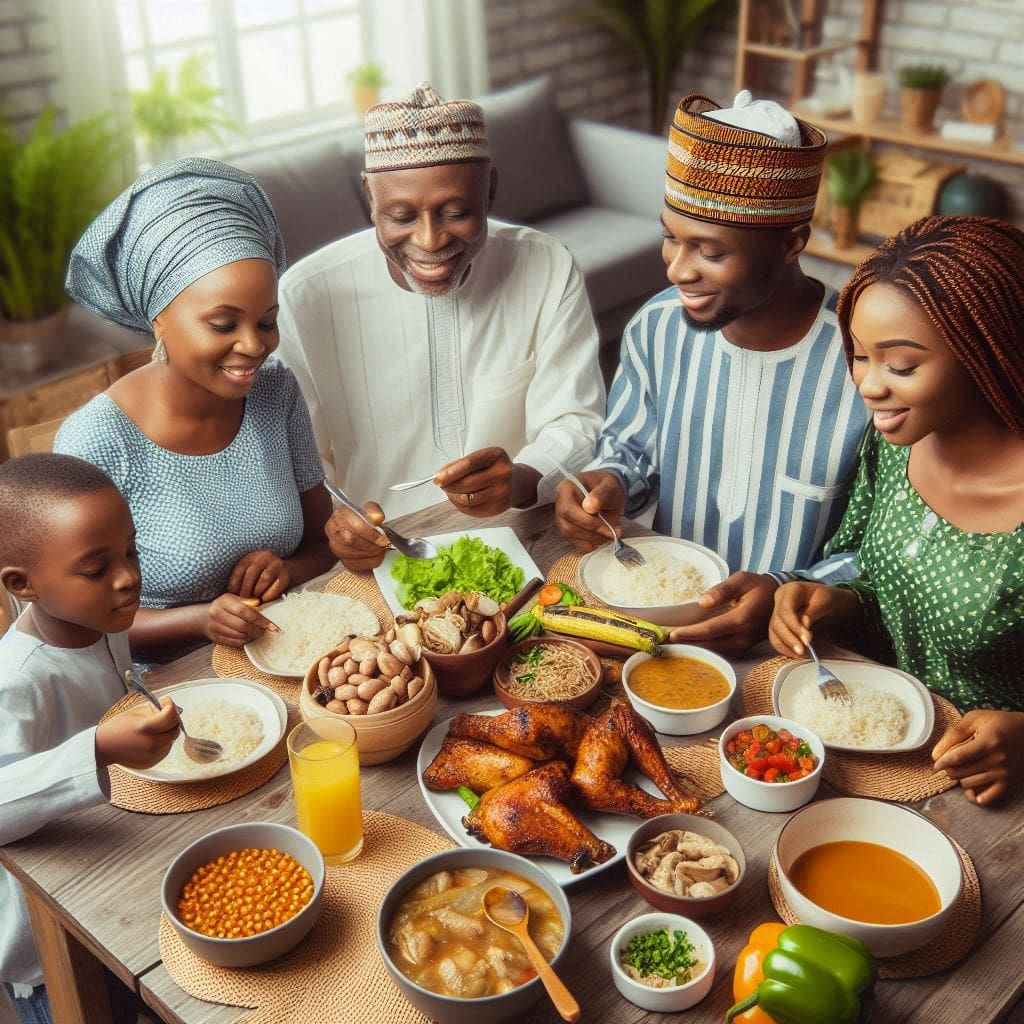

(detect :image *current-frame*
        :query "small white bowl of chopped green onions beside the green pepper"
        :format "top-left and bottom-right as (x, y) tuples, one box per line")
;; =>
(611, 913), (715, 1014)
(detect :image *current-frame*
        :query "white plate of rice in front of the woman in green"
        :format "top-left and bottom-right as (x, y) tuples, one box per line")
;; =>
(772, 658), (935, 754)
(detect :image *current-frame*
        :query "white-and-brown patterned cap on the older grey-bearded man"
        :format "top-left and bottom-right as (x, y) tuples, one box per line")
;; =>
(366, 82), (490, 171)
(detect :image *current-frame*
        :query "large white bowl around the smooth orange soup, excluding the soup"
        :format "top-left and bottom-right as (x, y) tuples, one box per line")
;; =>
(775, 797), (964, 956)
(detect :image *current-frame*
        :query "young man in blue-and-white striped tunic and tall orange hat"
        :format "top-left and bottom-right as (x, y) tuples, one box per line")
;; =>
(556, 92), (867, 651)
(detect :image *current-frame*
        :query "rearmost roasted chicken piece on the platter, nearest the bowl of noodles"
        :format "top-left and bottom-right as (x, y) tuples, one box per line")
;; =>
(447, 703), (591, 761)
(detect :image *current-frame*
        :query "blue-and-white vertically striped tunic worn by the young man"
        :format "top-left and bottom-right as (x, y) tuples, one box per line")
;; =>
(589, 288), (868, 572)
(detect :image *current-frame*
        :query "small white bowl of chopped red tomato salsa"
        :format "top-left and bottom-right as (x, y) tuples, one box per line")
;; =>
(719, 715), (825, 812)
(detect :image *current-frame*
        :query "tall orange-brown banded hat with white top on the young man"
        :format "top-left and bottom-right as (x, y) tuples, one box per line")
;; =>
(665, 90), (827, 227)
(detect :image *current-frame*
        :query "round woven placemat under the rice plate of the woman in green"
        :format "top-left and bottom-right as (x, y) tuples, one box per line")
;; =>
(742, 657), (961, 804)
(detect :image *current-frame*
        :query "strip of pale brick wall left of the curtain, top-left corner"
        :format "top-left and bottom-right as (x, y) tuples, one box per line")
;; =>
(0, 0), (59, 135)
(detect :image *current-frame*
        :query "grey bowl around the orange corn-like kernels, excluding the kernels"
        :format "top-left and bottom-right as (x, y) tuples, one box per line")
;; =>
(160, 821), (324, 967)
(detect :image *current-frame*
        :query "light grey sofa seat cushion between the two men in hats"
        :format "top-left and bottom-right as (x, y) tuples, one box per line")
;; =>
(534, 206), (667, 318)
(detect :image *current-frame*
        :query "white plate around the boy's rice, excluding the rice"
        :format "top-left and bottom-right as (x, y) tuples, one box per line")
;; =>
(123, 679), (288, 784)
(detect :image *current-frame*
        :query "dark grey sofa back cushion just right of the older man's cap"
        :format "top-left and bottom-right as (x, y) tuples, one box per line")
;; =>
(478, 78), (588, 224)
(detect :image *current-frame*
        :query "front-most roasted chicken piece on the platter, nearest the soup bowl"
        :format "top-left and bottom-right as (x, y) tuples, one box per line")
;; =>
(462, 761), (615, 874)
